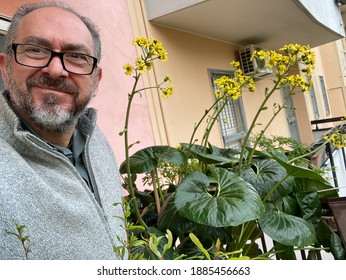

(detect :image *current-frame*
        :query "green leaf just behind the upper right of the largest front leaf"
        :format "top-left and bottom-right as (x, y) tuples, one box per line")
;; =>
(241, 159), (293, 201)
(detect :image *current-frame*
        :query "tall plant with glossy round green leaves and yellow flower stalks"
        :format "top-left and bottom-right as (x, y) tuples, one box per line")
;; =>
(115, 37), (345, 259)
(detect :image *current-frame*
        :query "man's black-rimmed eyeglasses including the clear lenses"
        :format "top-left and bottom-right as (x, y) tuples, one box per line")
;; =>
(12, 44), (97, 75)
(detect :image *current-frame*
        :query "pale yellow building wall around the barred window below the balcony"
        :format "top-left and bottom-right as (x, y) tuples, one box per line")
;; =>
(128, 0), (302, 149)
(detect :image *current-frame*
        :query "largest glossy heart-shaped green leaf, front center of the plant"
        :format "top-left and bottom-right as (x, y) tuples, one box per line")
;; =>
(175, 168), (264, 227)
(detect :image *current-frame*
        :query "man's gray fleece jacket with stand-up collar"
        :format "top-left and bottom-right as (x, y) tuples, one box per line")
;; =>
(0, 93), (126, 260)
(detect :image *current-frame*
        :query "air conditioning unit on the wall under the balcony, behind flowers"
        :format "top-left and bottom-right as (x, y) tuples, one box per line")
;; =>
(239, 45), (273, 78)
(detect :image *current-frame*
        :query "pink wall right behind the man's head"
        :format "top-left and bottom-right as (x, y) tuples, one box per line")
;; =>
(0, 0), (154, 164)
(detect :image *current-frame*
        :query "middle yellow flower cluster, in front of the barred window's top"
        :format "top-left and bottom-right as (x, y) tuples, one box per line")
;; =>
(215, 61), (255, 100)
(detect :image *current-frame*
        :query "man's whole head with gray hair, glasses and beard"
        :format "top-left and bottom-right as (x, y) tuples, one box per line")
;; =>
(0, 1), (102, 132)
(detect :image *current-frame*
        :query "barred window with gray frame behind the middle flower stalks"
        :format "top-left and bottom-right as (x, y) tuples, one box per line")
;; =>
(210, 71), (246, 148)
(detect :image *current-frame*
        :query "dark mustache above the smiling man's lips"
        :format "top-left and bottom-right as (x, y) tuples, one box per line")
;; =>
(26, 75), (79, 95)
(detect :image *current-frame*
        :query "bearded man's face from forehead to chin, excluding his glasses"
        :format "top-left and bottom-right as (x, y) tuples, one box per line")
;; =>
(0, 8), (101, 132)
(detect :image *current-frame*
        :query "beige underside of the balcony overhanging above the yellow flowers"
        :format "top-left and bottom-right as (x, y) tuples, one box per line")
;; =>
(146, 0), (343, 49)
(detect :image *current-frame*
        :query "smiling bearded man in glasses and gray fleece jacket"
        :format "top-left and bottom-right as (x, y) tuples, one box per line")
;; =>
(0, 1), (126, 259)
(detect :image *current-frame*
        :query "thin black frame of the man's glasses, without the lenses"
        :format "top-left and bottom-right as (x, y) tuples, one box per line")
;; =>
(10, 43), (98, 75)
